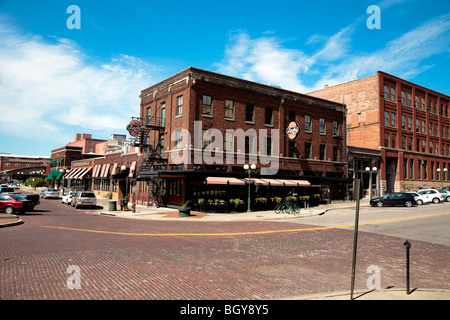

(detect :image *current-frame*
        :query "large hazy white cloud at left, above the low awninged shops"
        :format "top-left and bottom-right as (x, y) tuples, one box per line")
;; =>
(0, 21), (152, 141)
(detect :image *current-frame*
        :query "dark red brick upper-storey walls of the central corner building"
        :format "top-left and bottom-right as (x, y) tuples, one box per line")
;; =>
(140, 68), (347, 205)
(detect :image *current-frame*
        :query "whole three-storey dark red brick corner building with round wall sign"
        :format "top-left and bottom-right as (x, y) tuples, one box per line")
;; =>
(136, 67), (347, 208)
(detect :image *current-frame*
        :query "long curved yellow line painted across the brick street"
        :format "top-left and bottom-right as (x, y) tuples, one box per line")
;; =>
(43, 212), (450, 237)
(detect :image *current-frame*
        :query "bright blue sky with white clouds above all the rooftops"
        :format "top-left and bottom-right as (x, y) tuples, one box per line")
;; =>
(0, 0), (450, 155)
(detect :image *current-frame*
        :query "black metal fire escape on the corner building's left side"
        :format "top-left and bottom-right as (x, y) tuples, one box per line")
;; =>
(127, 114), (168, 207)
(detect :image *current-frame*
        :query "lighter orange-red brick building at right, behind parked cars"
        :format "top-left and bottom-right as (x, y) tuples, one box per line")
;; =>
(309, 71), (450, 192)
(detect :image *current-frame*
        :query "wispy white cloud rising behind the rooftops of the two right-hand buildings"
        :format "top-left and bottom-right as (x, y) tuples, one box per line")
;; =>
(217, 13), (450, 93)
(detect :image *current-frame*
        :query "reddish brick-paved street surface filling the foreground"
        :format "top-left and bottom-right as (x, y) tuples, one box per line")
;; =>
(0, 200), (450, 300)
